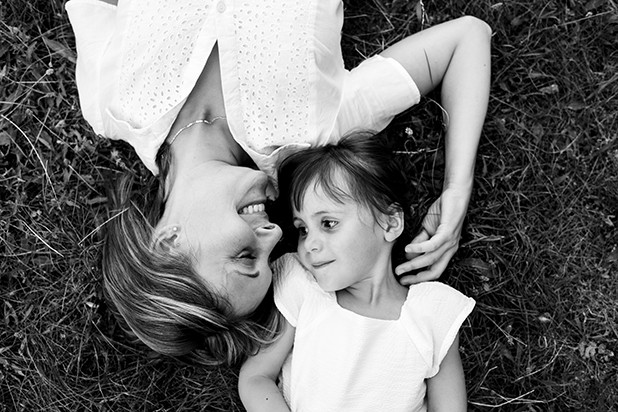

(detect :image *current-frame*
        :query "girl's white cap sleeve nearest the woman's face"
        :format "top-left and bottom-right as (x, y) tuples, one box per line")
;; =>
(274, 253), (314, 327)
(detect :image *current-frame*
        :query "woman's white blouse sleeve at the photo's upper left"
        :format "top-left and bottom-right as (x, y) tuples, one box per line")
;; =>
(65, 0), (117, 134)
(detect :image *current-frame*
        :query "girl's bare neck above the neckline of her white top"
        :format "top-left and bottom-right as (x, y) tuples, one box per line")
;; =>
(336, 259), (408, 320)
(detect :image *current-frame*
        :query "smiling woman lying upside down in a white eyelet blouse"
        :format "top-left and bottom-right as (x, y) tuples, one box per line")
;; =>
(67, 0), (490, 363)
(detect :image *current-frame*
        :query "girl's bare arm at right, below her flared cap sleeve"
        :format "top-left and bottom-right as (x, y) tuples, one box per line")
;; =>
(427, 337), (467, 412)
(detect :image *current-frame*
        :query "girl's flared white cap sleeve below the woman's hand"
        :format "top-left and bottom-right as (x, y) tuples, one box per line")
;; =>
(406, 282), (476, 378)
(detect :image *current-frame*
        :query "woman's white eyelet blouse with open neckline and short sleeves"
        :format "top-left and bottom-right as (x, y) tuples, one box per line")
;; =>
(66, 0), (420, 174)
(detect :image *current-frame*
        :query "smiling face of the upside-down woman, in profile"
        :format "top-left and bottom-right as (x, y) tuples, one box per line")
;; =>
(159, 162), (281, 315)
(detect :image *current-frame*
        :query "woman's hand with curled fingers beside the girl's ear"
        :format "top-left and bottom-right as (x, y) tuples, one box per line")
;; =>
(395, 188), (470, 285)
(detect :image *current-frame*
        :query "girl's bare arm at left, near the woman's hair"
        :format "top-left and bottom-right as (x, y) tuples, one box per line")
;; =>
(238, 321), (296, 412)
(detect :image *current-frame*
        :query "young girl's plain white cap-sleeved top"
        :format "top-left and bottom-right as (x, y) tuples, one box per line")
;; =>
(275, 255), (475, 412)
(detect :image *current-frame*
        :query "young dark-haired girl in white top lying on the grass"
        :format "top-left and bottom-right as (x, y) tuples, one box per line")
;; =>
(239, 135), (474, 412)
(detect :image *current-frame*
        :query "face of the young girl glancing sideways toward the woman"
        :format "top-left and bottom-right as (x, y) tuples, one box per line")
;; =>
(293, 181), (390, 292)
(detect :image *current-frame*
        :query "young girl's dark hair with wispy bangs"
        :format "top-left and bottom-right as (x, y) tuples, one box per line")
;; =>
(278, 131), (418, 266)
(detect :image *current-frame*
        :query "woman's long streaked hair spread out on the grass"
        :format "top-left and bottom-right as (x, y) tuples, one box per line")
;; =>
(102, 143), (280, 365)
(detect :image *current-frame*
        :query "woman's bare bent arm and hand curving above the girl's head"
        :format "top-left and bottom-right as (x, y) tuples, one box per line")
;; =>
(382, 17), (491, 284)
